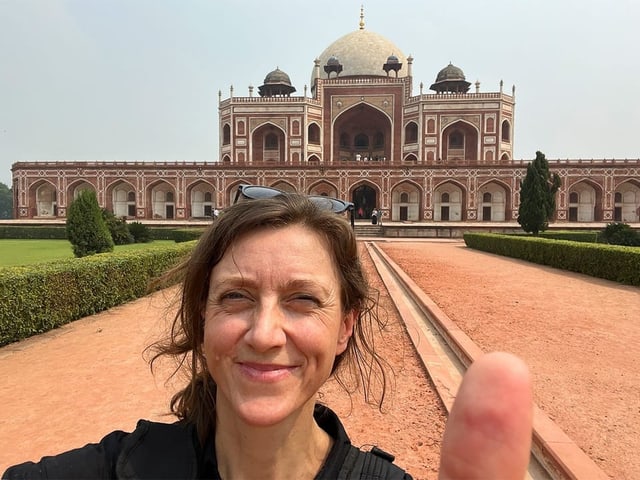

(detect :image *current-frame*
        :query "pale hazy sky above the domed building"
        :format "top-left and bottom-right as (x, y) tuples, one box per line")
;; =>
(0, 0), (640, 184)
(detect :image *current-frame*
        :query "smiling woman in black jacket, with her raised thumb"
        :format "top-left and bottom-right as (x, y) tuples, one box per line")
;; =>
(3, 194), (530, 479)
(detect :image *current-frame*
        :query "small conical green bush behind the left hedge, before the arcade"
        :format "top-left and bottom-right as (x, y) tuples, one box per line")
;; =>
(67, 190), (113, 257)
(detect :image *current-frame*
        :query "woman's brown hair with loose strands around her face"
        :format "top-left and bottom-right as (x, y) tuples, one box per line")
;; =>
(149, 194), (387, 441)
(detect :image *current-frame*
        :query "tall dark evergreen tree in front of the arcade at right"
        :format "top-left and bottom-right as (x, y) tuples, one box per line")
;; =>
(518, 152), (561, 235)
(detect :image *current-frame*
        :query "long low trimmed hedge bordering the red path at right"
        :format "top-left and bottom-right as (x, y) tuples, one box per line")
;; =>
(464, 233), (640, 286)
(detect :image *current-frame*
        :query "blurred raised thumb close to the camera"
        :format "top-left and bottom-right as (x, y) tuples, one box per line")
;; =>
(439, 352), (533, 480)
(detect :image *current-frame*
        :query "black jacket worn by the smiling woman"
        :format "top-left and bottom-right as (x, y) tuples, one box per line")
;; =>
(2, 405), (411, 480)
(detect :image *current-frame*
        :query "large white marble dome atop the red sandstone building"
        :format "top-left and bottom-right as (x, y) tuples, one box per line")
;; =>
(311, 29), (408, 85)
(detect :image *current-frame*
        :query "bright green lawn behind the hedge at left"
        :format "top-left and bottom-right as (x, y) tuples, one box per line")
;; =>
(0, 239), (175, 267)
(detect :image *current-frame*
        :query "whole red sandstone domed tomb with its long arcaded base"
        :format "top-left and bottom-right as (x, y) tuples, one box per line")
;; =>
(12, 15), (640, 223)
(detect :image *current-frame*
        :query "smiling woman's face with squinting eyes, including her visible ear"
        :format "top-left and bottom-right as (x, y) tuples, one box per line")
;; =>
(203, 225), (355, 426)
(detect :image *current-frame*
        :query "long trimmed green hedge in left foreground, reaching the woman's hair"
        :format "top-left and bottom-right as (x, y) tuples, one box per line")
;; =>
(0, 242), (195, 346)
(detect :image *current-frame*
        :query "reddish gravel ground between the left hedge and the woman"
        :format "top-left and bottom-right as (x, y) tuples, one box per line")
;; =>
(0, 290), (181, 474)
